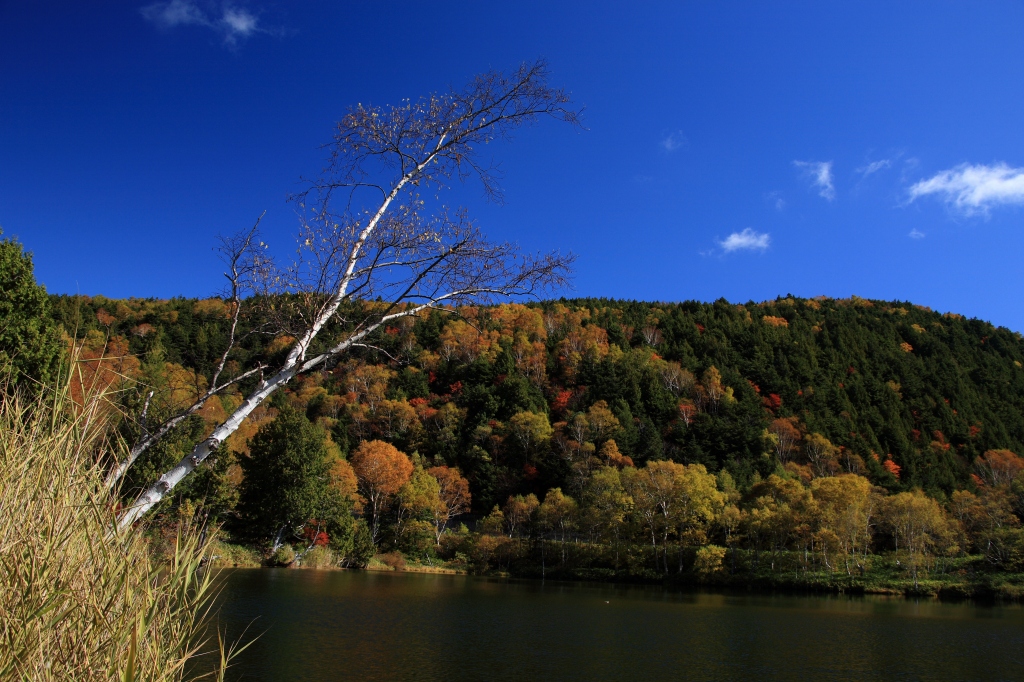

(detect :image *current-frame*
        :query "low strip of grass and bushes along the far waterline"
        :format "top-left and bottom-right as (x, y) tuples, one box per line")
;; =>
(197, 520), (1024, 602)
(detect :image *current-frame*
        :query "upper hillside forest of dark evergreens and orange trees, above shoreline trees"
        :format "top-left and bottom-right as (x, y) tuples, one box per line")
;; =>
(52, 297), (1024, 503)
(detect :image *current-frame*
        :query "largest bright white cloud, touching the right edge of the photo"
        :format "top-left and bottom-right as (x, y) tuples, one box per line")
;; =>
(909, 163), (1024, 215)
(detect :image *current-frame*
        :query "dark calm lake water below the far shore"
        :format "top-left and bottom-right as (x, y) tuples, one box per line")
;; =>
(209, 569), (1024, 682)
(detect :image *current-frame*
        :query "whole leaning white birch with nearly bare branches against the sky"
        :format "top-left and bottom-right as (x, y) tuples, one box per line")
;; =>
(114, 61), (579, 528)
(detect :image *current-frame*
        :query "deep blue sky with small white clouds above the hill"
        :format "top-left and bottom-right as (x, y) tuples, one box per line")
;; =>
(0, 0), (1024, 331)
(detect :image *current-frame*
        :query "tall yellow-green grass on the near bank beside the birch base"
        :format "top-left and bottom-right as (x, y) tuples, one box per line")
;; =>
(0, 378), (229, 682)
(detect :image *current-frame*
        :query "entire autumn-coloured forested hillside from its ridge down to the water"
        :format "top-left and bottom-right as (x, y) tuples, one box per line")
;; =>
(44, 297), (1024, 598)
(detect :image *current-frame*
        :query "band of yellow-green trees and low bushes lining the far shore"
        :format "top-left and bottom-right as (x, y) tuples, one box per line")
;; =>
(193, 454), (1024, 601)
